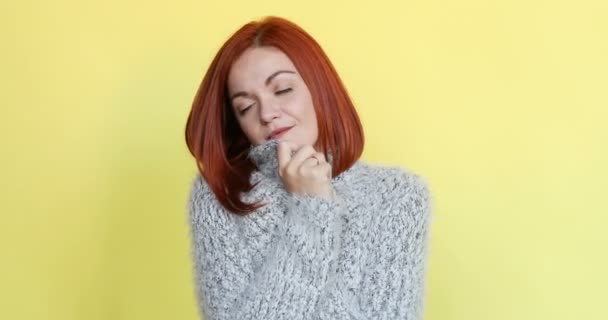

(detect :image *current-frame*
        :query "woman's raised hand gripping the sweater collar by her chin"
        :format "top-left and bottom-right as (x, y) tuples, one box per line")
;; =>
(277, 140), (335, 200)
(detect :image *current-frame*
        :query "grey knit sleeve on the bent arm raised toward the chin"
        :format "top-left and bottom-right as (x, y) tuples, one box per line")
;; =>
(190, 175), (354, 320)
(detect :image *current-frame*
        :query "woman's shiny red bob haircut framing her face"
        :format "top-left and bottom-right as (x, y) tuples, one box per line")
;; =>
(185, 16), (364, 216)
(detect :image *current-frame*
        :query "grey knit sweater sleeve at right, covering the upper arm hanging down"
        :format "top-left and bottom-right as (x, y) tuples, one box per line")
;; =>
(362, 169), (431, 320)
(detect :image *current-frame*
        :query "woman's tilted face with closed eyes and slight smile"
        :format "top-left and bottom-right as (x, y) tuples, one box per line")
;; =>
(228, 47), (318, 150)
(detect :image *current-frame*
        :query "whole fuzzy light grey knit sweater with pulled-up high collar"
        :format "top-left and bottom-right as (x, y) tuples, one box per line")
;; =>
(188, 140), (431, 320)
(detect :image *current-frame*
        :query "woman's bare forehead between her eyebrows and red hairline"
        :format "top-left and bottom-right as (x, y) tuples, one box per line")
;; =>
(228, 47), (297, 91)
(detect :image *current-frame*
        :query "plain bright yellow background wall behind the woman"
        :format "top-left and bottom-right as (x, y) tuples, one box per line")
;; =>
(0, 0), (608, 320)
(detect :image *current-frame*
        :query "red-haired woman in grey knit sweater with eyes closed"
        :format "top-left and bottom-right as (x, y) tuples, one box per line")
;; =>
(186, 17), (431, 320)
